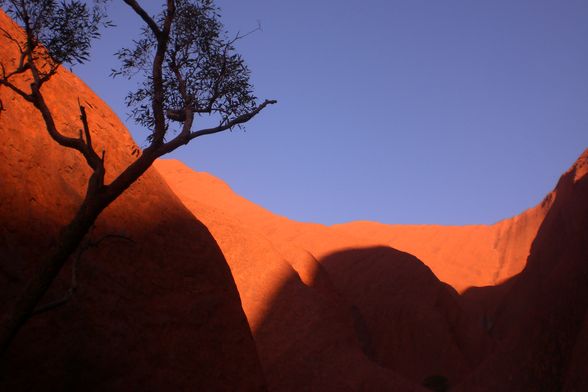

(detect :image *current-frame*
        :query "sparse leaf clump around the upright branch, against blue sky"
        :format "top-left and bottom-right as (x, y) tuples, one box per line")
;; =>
(112, 0), (257, 138)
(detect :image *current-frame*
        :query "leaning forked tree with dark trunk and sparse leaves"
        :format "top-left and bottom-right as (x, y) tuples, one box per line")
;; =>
(0, 0), (276, 355)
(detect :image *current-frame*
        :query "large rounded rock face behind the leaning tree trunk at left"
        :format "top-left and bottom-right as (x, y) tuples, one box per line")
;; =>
(0, 13), (265, 391)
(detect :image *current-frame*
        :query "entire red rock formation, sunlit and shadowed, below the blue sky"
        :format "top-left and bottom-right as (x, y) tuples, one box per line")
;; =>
(0, 6), (588, 391)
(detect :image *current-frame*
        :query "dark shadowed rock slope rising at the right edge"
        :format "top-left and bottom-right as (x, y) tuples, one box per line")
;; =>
(459, 150), (588, 391)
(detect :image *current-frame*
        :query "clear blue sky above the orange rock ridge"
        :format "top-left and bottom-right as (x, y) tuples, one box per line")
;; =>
(74, 0), (588, 225)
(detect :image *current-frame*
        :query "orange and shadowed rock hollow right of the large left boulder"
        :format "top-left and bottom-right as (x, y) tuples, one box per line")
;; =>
(156, 147), (588, 391)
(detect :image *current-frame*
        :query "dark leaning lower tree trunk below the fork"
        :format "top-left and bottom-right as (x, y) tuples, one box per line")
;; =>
(0, 199), (101, 358)
